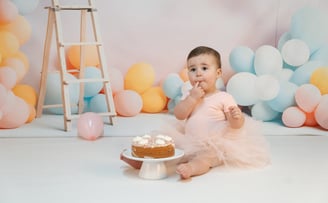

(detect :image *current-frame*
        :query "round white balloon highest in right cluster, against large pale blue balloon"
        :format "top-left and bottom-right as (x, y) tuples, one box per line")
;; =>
(281, 39), (310, 66)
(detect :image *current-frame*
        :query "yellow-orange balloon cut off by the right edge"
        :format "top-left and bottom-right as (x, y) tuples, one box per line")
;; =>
(310, 67), (328, 95)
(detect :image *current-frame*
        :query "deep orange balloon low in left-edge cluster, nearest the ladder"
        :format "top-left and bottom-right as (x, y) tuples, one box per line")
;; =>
(12, 84), (37, 106)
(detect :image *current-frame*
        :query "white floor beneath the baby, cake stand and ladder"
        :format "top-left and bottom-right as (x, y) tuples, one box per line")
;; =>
(0, 114), (328, 203)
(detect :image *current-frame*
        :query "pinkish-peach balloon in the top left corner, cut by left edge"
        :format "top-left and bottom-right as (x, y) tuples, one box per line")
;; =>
(0, 0), (18, 24)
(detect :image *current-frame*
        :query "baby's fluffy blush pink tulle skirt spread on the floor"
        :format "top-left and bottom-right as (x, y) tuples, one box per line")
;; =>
(162, 115), (270, 168)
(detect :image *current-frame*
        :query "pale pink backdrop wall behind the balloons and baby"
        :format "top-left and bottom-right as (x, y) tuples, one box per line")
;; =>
(21, 0), (328, 89)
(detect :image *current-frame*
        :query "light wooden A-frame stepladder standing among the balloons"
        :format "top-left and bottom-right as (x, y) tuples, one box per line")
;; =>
(36, 0), (116, 131)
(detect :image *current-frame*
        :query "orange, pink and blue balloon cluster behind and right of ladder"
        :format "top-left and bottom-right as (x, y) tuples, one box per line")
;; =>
(45, 46), (167, 117)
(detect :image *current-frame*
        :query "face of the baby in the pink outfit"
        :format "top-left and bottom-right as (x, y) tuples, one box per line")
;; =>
(187, 54), (221, 93)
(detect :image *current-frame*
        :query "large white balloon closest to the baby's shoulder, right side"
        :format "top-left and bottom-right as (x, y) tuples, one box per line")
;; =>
(227, 72), (259, 106)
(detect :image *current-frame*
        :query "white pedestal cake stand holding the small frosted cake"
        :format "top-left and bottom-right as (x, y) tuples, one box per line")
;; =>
(123, 149), (184, 180)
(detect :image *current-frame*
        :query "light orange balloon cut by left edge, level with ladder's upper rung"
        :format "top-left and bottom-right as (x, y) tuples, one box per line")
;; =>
(0, 31), (19, 58)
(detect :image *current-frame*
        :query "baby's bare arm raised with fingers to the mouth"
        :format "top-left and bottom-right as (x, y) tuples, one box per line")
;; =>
(174, 83), (205, 120)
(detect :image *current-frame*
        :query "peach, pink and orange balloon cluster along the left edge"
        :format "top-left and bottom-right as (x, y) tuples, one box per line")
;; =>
(0, 0), (39, 128)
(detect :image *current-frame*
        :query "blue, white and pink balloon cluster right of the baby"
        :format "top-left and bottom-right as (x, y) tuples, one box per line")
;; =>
(226, 7), (328, 129)
